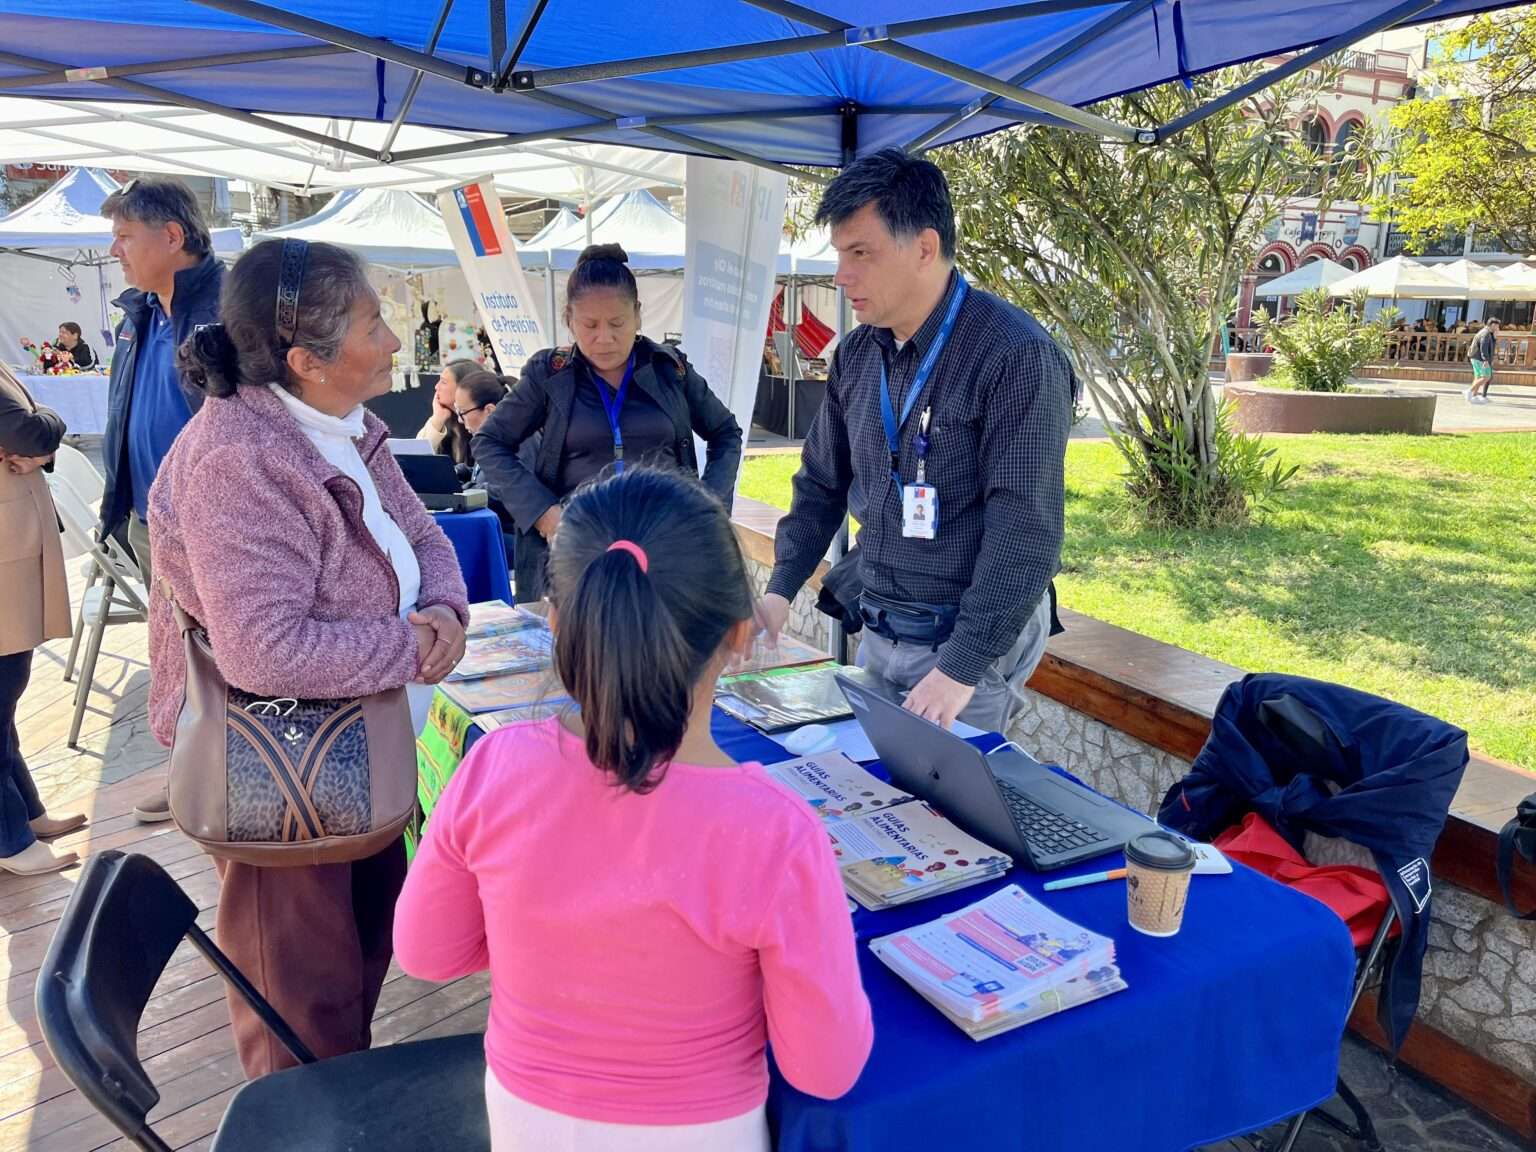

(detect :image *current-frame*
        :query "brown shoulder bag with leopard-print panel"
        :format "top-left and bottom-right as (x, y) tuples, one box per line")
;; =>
(160, 581), (416, 866)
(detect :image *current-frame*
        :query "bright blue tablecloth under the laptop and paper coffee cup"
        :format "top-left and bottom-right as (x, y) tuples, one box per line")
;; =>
(465, 711), (1355, 1152)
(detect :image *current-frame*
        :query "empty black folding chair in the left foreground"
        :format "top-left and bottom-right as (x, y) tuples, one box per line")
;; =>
(37, 852), (490, 1152)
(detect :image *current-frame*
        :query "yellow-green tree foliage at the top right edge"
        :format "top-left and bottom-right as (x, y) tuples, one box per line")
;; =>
(1375, 9), (1536, 252)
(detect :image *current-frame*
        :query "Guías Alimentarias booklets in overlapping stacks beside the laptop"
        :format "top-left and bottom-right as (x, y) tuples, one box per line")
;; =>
(766, 753), (1014, 911)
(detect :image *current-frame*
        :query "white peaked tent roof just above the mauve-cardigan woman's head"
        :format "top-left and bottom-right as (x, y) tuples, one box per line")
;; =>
(252, 187), (459, 267)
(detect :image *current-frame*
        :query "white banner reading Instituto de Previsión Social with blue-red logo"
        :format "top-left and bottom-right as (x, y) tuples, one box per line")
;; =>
(438, 180), (548, 376)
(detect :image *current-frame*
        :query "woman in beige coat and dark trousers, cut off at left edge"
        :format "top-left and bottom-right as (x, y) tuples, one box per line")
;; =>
(0, 366), (86, 876)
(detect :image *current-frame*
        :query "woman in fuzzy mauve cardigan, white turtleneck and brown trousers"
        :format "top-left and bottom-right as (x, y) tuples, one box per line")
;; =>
(149, 240), (468, 1077)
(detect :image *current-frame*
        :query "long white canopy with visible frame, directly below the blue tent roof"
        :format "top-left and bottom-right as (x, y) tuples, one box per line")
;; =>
(0, 95), (685, 203)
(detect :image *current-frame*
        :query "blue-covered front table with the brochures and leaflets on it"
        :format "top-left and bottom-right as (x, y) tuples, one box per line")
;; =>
(415, 605), (1355, 1152)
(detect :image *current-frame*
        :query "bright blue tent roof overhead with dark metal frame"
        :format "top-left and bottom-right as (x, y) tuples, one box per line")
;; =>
(0, 0), (1504, 166)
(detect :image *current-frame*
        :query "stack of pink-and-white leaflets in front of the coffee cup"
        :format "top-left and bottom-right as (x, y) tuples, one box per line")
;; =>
(869, 885), (1126, 1040)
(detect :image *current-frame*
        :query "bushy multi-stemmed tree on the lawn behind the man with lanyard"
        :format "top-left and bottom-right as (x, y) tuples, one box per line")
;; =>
(935, 66), (1369, 527)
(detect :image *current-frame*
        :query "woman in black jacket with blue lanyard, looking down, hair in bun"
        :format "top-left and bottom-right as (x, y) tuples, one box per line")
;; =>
(475, 244), (742, 604)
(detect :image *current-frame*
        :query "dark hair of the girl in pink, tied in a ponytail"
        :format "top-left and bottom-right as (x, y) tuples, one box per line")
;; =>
(548, 468), (753, 793)
